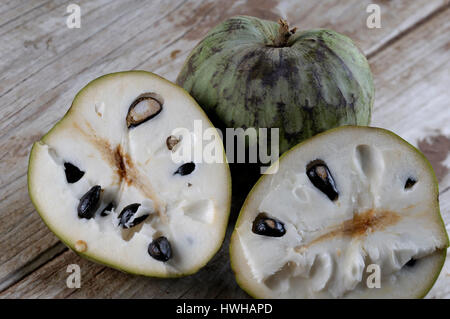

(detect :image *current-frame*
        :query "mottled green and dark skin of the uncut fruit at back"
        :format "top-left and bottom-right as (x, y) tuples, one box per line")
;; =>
(177, 16), (374, 153)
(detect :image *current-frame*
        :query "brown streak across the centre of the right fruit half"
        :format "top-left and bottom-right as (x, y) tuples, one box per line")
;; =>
(295, 209), (400, 252)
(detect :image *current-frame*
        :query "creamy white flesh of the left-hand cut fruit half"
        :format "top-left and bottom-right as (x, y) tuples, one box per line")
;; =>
(28, 71), (231, 276)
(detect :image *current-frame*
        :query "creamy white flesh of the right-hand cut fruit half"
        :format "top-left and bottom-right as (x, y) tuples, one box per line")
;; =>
(231, 127), (448, 298)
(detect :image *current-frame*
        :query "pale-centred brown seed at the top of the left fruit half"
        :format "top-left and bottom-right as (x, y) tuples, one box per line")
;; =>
(126, 93), (164, 128)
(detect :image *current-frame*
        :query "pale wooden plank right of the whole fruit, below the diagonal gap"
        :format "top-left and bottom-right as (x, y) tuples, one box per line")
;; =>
(370, 8), (450, 190)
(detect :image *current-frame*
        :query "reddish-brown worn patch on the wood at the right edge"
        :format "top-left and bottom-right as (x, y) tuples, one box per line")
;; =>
(418, 135), (450, 182)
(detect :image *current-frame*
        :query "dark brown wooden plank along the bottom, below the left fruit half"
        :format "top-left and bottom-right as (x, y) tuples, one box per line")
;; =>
(0, 228), (248, 298)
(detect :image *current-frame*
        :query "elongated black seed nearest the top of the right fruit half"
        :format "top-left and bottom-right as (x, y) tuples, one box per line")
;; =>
(306, 160), (339, 201)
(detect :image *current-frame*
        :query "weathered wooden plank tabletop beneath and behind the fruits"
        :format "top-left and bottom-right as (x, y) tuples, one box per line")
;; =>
(0, 0), (450, 298)
